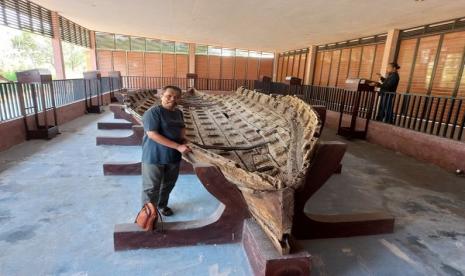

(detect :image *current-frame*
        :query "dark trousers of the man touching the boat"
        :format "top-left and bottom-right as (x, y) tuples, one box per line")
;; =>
(142, 163), (180, 209)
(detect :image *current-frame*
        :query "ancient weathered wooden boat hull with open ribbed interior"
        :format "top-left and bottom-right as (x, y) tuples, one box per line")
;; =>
(119, 87), (321, 254)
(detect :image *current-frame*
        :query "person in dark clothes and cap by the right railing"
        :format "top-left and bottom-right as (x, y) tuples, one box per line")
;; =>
(370, 62), (400, 124)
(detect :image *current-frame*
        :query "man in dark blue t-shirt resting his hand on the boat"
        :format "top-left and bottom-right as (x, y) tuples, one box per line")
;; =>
(142, 86), (191, 216)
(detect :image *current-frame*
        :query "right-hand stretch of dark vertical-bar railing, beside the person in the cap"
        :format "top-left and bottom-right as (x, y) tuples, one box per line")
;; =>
(255, 82), (465, 141)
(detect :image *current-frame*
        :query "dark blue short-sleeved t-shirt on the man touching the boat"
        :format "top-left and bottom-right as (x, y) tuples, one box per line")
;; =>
(142, 105), (185, 165)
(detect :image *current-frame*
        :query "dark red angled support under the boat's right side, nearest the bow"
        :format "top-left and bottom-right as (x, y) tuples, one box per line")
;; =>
(292, 142), (394, 239)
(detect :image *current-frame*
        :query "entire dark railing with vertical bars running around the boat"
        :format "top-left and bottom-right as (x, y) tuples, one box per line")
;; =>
(0, 76), (465, 141)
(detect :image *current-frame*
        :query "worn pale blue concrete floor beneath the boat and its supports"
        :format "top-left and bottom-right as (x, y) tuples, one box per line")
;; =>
(0, 108), (465, 275)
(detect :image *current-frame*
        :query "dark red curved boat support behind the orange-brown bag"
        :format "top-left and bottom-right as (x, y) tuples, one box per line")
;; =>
(113, 164), (249, 251)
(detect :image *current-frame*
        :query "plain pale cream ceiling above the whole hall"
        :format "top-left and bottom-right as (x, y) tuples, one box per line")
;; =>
(33, 0), (465, 51)
